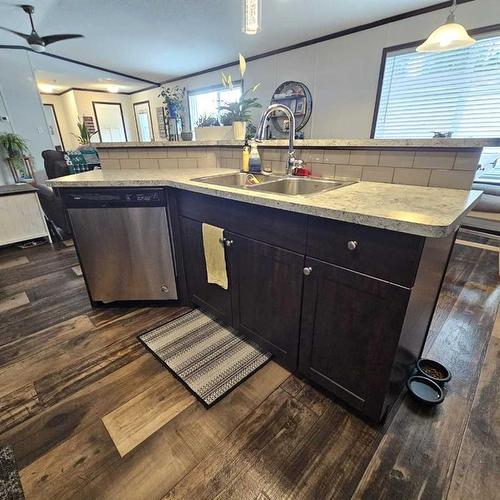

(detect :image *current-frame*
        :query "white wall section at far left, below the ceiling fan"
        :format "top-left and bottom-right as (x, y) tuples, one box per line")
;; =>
(0, 49), (53, 182)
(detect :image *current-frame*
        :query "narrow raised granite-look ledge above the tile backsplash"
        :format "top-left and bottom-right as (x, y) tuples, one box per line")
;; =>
(93, 139), (500, 149)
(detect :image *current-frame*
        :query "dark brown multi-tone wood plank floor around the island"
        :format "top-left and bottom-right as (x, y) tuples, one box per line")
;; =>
(0, 233), (500, 500)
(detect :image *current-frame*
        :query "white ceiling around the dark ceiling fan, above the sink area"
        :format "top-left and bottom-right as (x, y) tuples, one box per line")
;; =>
(0, 0), (444, 81)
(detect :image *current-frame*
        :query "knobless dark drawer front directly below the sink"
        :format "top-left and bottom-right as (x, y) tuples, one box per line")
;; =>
(176, 190), (307, 254)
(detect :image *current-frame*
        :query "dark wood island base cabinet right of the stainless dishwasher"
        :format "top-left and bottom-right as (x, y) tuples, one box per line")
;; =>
(169, 190), (454, 421)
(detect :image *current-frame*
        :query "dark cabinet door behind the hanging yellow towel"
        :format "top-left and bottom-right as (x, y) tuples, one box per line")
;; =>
(179, 217), (231, 323)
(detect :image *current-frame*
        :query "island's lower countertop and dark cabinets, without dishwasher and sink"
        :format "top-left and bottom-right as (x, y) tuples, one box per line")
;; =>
(50, 168), (481, 421)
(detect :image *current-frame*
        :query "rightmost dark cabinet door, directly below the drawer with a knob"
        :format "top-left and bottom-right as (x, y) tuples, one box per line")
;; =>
(299, 258), (410, 420)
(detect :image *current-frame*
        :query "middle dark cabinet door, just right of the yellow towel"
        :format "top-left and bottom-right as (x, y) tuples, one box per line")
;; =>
(227, 233), (304, 369)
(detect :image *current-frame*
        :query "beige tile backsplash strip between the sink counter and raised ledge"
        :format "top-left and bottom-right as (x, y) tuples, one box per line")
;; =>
(99, 147), (481, 189)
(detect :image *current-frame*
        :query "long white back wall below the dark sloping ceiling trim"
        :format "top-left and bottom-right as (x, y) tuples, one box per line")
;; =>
(131, 0), (500, 138)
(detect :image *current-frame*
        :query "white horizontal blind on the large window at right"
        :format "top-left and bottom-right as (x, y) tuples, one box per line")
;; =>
(375, 34), (500, 139)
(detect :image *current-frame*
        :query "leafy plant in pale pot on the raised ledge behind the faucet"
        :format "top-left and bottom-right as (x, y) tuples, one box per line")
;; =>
(218, 54), (262, 141)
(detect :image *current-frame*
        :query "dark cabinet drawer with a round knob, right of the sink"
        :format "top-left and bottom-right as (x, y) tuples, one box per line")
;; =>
(306, 217), (424, 287)
